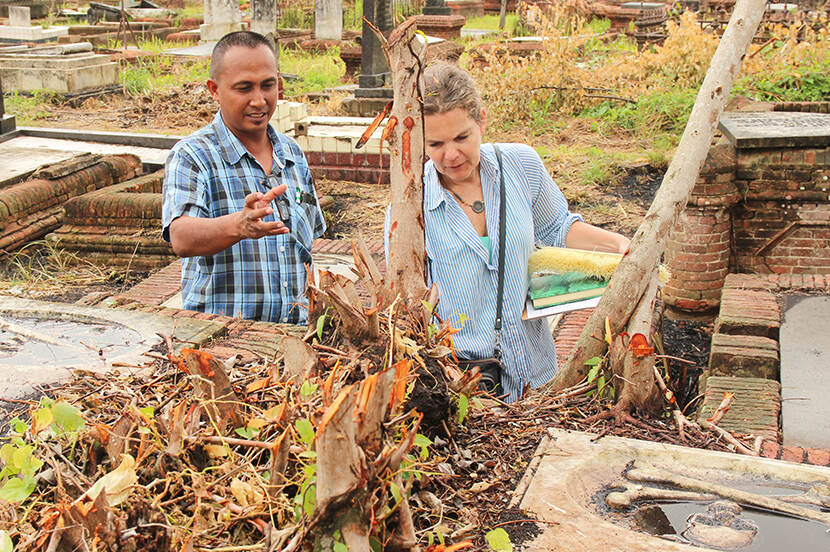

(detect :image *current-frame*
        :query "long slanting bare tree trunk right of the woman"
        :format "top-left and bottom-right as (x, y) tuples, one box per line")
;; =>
(549, 0), (765, 392)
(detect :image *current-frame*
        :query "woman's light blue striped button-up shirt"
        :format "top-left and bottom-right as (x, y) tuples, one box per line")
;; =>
(386, 144), (582, 402)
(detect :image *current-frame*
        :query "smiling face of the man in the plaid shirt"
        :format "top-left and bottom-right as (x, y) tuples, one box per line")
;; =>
(207, 45), (278, 140)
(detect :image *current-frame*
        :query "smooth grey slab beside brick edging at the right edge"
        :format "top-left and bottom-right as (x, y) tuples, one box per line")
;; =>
(780, 295), (830, 448)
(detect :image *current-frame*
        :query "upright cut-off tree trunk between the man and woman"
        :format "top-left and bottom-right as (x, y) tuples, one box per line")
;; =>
(377, 17), (427, 307)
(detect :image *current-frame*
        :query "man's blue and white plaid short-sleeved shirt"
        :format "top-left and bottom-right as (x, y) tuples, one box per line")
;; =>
(162, 112), (326, 324)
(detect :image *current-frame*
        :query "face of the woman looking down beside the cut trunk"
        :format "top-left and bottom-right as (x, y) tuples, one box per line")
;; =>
(424, 107), (485, 186)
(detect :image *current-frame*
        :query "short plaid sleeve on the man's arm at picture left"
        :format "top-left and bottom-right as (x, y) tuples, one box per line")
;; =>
(161, 149), (210, 242)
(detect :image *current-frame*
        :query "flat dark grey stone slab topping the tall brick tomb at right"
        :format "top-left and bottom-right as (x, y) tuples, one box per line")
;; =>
(719, 111), (830, 149)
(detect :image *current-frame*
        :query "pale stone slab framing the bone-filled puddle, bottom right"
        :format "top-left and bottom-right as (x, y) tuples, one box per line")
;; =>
(510, 429), (830, 552)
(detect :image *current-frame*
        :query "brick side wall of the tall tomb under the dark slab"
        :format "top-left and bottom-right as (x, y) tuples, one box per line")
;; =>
(733, 147), (830, 274)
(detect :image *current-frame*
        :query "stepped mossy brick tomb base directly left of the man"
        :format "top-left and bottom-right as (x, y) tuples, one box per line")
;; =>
(47, 170), (176, 270)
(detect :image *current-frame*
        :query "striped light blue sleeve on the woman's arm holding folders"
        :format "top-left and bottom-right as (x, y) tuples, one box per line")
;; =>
(523, 148), (582, 247)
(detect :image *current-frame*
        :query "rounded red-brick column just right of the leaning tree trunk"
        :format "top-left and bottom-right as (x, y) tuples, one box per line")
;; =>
(663, 144), (740, 312)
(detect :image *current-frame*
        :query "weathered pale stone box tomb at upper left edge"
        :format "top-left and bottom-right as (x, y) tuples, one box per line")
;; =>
(0, 46), (118, 94)
